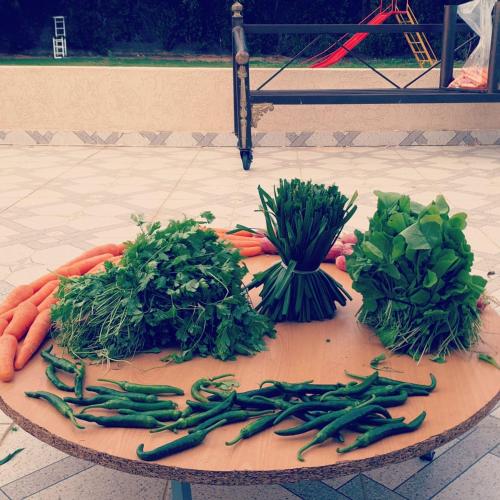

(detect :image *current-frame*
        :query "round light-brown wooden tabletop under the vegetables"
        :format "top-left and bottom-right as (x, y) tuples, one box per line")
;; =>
(0, 256), (500, 484)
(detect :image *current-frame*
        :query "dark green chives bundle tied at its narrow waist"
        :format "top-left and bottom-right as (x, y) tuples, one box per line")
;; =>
(249, 179), (357, 322)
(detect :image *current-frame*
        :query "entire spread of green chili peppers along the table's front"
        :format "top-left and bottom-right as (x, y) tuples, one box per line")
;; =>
(26, 358), (437, 461)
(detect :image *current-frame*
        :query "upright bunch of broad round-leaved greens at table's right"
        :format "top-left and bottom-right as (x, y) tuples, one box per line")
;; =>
(347, 192), (486, 358)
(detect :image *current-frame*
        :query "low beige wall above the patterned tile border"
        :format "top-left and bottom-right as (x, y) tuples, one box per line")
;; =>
(0, 66), (500, 133)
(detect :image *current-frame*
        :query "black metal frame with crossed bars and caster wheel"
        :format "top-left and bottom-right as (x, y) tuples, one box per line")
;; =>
(231, 0), (500, 170)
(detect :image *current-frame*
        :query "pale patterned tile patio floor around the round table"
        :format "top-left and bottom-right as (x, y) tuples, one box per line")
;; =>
(0, 146), (500, 500)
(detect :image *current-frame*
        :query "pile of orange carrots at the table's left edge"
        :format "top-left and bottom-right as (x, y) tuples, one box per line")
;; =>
(0, 243), (125, 382)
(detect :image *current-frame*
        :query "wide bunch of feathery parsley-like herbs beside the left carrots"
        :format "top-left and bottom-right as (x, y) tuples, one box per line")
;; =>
(53, 212), (274, 361)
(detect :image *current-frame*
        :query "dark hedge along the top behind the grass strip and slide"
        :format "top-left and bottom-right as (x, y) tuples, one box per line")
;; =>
(0, 0), (454, 56)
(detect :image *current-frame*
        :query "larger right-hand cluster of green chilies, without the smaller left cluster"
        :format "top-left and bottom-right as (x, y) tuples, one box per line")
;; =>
(133, 371), (436, 460)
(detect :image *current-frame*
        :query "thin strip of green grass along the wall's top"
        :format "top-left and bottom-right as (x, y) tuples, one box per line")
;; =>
(0, 56), (438, 68)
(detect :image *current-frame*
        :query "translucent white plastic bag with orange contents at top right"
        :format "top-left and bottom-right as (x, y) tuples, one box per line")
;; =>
(450, 0), (497, 89)
